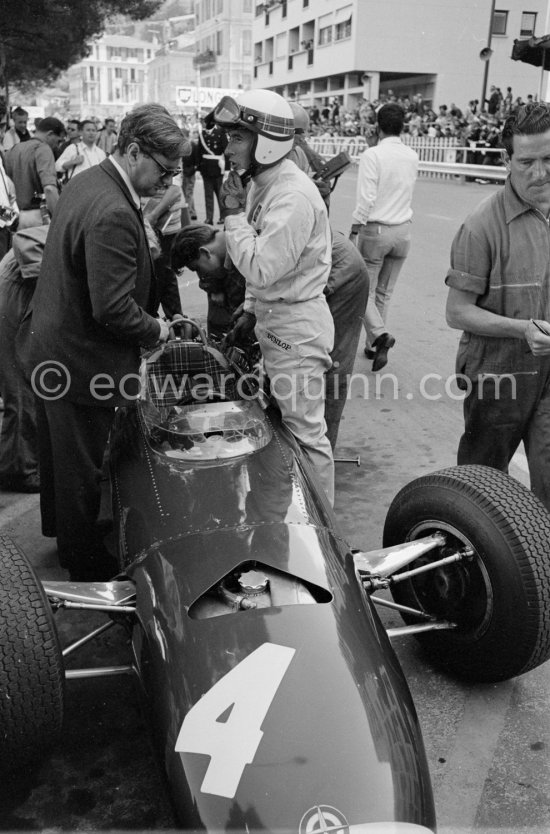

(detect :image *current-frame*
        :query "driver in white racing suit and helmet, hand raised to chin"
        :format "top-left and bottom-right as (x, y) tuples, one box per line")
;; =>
(213, 90), (334, 503)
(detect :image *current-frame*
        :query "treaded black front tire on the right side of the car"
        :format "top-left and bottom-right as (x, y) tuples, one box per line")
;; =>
(384, 466), (550, 681)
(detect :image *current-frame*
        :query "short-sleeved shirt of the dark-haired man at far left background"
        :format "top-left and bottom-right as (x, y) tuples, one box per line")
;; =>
(5, 138), (57, 211)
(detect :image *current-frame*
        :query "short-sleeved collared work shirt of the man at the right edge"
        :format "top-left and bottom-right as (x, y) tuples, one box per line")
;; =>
(445, 179), (550, 379)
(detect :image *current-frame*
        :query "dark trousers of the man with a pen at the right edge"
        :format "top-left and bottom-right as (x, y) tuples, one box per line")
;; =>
(457, 357), (550, 510)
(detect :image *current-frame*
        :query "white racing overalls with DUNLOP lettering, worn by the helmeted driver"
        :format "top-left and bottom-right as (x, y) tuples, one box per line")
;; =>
(225, 160), (334, 503)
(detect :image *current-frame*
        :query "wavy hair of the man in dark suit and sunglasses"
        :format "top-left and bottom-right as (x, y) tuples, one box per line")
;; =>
(117, 104), (191, 159)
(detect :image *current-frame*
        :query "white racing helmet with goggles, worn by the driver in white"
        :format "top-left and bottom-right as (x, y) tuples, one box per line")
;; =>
(214, 90), (294, 168)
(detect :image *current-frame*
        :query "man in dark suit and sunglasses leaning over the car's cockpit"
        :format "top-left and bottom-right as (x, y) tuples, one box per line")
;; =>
(30, 104), (188, 581)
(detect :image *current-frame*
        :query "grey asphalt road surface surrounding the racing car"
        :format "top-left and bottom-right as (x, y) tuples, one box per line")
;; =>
(0, 172), (550, 834)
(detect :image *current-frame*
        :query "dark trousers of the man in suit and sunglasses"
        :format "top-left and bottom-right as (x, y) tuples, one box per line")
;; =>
(36, 397), (116, 581)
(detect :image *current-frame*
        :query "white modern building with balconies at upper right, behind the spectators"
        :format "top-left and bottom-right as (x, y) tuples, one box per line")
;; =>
(253, 0), (550, 109)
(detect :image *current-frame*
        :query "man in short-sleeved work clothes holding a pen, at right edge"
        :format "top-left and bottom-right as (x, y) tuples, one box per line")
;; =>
(446, 102), (550, 511)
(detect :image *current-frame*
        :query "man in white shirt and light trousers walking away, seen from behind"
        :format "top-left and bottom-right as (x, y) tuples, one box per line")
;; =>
(350, 103), (418, 371)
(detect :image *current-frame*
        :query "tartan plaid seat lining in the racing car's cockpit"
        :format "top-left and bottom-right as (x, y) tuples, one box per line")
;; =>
(144, 341), (238, 408)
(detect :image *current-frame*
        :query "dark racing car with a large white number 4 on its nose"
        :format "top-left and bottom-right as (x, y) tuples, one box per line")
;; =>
(0, 320), (550, 834)
